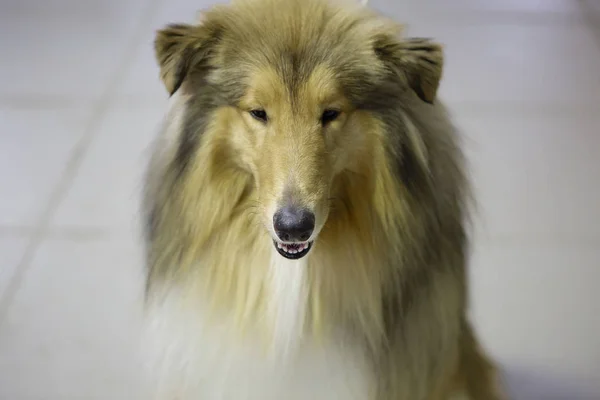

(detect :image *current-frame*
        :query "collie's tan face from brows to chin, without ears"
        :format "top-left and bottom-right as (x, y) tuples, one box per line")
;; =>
(231, 65), (361, 259)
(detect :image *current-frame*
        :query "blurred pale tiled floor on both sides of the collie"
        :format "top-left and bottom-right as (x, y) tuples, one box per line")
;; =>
(0, 0), (600, 400)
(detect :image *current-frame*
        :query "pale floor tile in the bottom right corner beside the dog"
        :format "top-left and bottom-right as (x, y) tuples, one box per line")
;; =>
(471, 240), (600, 400)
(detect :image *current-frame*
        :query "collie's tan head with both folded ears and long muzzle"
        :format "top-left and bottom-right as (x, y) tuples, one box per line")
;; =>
(155, 0), (442, 259)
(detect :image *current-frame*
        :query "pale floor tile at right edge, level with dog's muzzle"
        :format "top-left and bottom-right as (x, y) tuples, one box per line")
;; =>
(455, 108), (600, 243)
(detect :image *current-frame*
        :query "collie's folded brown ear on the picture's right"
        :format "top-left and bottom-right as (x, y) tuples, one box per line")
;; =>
(374, 34), (444, 104)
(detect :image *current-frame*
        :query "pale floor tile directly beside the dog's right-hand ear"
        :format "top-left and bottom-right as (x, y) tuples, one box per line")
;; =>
(400, 18), (600, 108)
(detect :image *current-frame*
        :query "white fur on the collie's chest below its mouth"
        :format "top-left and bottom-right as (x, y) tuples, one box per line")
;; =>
(144, 256), (371, 400)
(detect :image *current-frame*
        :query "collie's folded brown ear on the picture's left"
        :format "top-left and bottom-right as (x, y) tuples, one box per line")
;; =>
(154, 24), (216, 95)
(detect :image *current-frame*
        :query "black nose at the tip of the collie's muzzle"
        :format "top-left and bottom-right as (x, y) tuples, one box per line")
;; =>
(273, 207), (315, 242)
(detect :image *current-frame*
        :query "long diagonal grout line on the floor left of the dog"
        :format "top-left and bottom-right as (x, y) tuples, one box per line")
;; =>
(0, 0), (162, 327)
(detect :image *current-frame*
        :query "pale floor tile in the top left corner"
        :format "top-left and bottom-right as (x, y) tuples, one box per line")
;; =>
(0, 0), (145, 98)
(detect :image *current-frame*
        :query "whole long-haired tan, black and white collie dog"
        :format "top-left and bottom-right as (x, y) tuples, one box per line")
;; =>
(144, 0), (500, 400)
